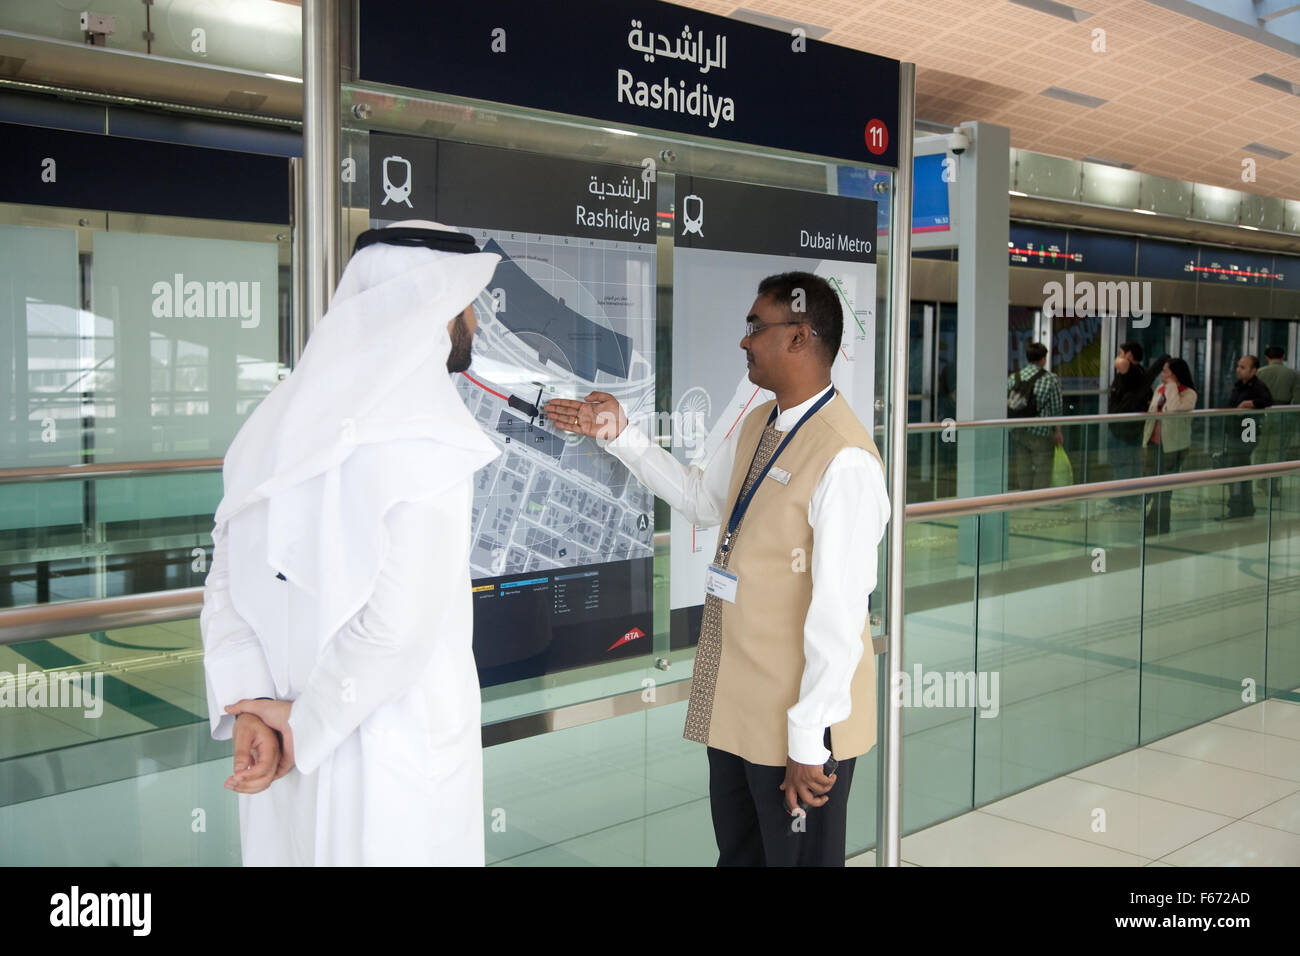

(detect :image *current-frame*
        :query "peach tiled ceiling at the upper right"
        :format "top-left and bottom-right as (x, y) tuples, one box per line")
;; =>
(684, 0), (1300, 199)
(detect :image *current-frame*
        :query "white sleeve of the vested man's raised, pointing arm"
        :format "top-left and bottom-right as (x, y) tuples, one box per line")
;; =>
(605, 423), (740, 528)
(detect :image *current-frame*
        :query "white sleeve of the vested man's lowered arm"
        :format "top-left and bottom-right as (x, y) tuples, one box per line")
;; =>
(787, 447), (889, 766)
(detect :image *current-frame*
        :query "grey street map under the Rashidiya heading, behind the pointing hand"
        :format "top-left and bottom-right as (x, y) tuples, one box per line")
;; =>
(455, 226), (655, 579)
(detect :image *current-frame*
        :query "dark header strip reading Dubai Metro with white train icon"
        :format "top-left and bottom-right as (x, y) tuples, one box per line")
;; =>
(672, 176), (876, 263)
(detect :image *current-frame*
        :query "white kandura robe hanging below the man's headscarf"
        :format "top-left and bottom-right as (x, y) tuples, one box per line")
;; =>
(204, 480), (484, 866)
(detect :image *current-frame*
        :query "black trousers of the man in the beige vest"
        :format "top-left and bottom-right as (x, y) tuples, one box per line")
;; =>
(709, 731), (857, 866)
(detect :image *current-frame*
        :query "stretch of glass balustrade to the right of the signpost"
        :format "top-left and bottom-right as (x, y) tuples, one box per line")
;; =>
(901, 476), (1300, 848)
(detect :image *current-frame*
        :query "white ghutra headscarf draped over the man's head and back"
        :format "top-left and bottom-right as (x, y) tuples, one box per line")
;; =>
(213, 220), (499, 693)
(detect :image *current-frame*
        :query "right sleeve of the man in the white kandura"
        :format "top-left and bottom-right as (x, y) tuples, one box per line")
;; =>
(289, 496), (468, 774)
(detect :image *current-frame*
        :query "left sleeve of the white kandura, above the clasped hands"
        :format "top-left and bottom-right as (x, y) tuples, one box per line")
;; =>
(199, 527), (276, 740)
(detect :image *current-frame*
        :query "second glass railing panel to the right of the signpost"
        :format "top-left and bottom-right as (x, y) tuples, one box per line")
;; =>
(974, 501), (1143, 805)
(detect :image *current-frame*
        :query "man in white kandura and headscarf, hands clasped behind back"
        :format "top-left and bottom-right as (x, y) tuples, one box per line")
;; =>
(200, 221), (499, 865)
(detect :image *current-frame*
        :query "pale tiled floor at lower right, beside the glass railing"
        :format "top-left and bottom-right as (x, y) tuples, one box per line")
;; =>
(852, 700), (1300, 866)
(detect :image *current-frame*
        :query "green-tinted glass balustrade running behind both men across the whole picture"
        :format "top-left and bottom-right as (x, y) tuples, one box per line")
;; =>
(0, 476), (1300, 866)
